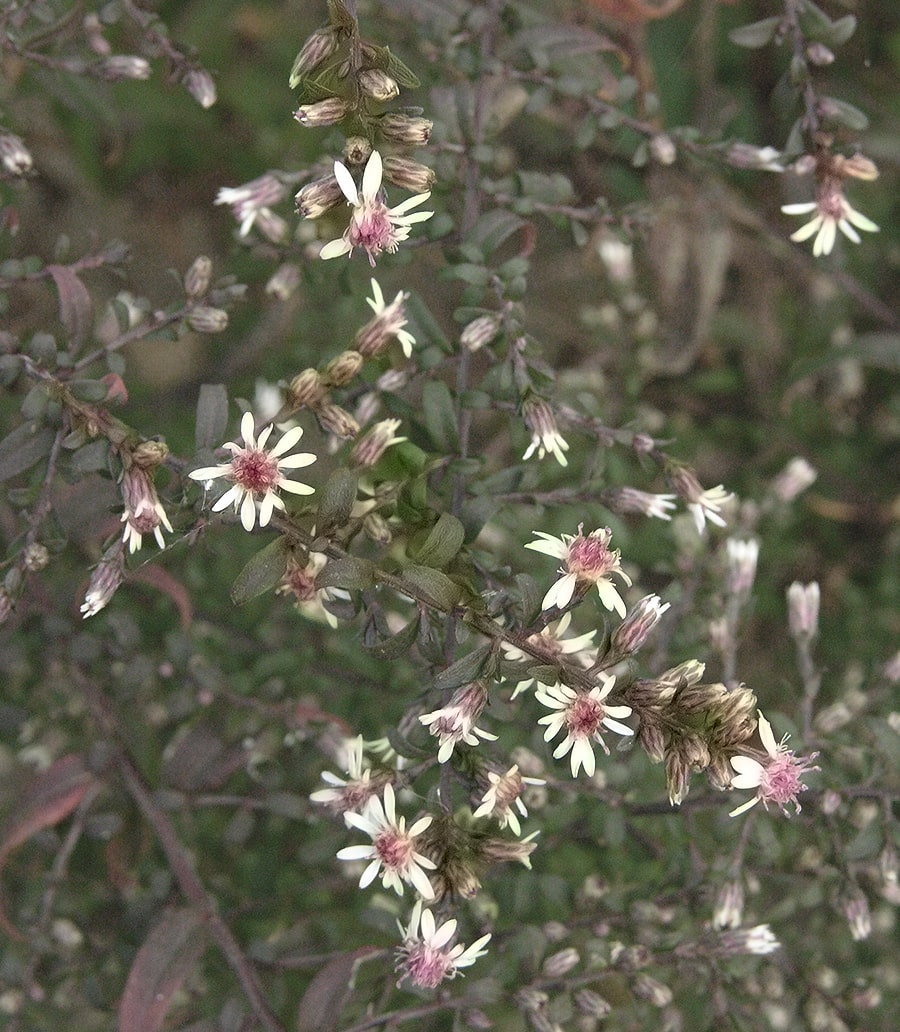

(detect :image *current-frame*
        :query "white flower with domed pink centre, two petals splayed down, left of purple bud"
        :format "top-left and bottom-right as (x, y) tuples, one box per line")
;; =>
(525, 524), (632, 617)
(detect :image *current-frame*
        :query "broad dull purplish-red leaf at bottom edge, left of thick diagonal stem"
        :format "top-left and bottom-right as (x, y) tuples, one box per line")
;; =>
(119, 909), (204, 1032)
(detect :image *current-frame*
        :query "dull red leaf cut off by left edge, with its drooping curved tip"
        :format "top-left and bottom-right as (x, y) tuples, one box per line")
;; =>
(0, 753), (96, 939)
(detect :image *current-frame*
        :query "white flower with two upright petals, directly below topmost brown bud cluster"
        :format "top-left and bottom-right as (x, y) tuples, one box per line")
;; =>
(319, 151), (435, 267)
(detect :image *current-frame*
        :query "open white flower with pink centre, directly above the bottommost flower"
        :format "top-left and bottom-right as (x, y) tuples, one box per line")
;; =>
(338, 783), (438, 900)
